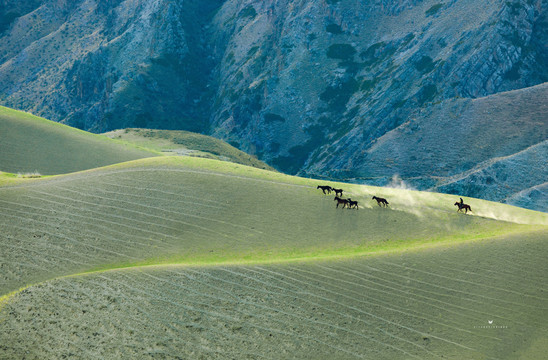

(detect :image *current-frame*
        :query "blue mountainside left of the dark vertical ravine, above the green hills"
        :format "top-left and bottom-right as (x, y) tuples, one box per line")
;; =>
(0, 0), (225, 132)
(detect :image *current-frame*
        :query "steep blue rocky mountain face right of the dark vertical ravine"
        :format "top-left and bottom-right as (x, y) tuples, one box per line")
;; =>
(208, 0), (548, 174)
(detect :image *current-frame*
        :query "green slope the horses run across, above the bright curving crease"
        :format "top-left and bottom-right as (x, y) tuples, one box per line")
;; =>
(0, 157), (548, 294)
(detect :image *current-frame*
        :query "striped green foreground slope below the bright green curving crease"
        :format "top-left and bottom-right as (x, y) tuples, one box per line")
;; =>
(0, 232), (548, 359)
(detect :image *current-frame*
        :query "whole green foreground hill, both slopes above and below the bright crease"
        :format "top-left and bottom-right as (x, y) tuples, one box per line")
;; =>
(0, 157), (548, 359)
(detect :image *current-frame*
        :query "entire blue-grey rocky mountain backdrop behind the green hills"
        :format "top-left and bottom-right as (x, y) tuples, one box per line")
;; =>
(0, 0), (548, 211)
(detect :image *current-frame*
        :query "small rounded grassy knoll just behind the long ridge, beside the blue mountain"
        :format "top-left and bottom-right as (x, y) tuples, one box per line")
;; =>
(103, 128), (274, 171)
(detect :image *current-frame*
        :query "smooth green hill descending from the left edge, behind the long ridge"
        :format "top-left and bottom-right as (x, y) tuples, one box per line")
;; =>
(0, 106), (159, 175)
